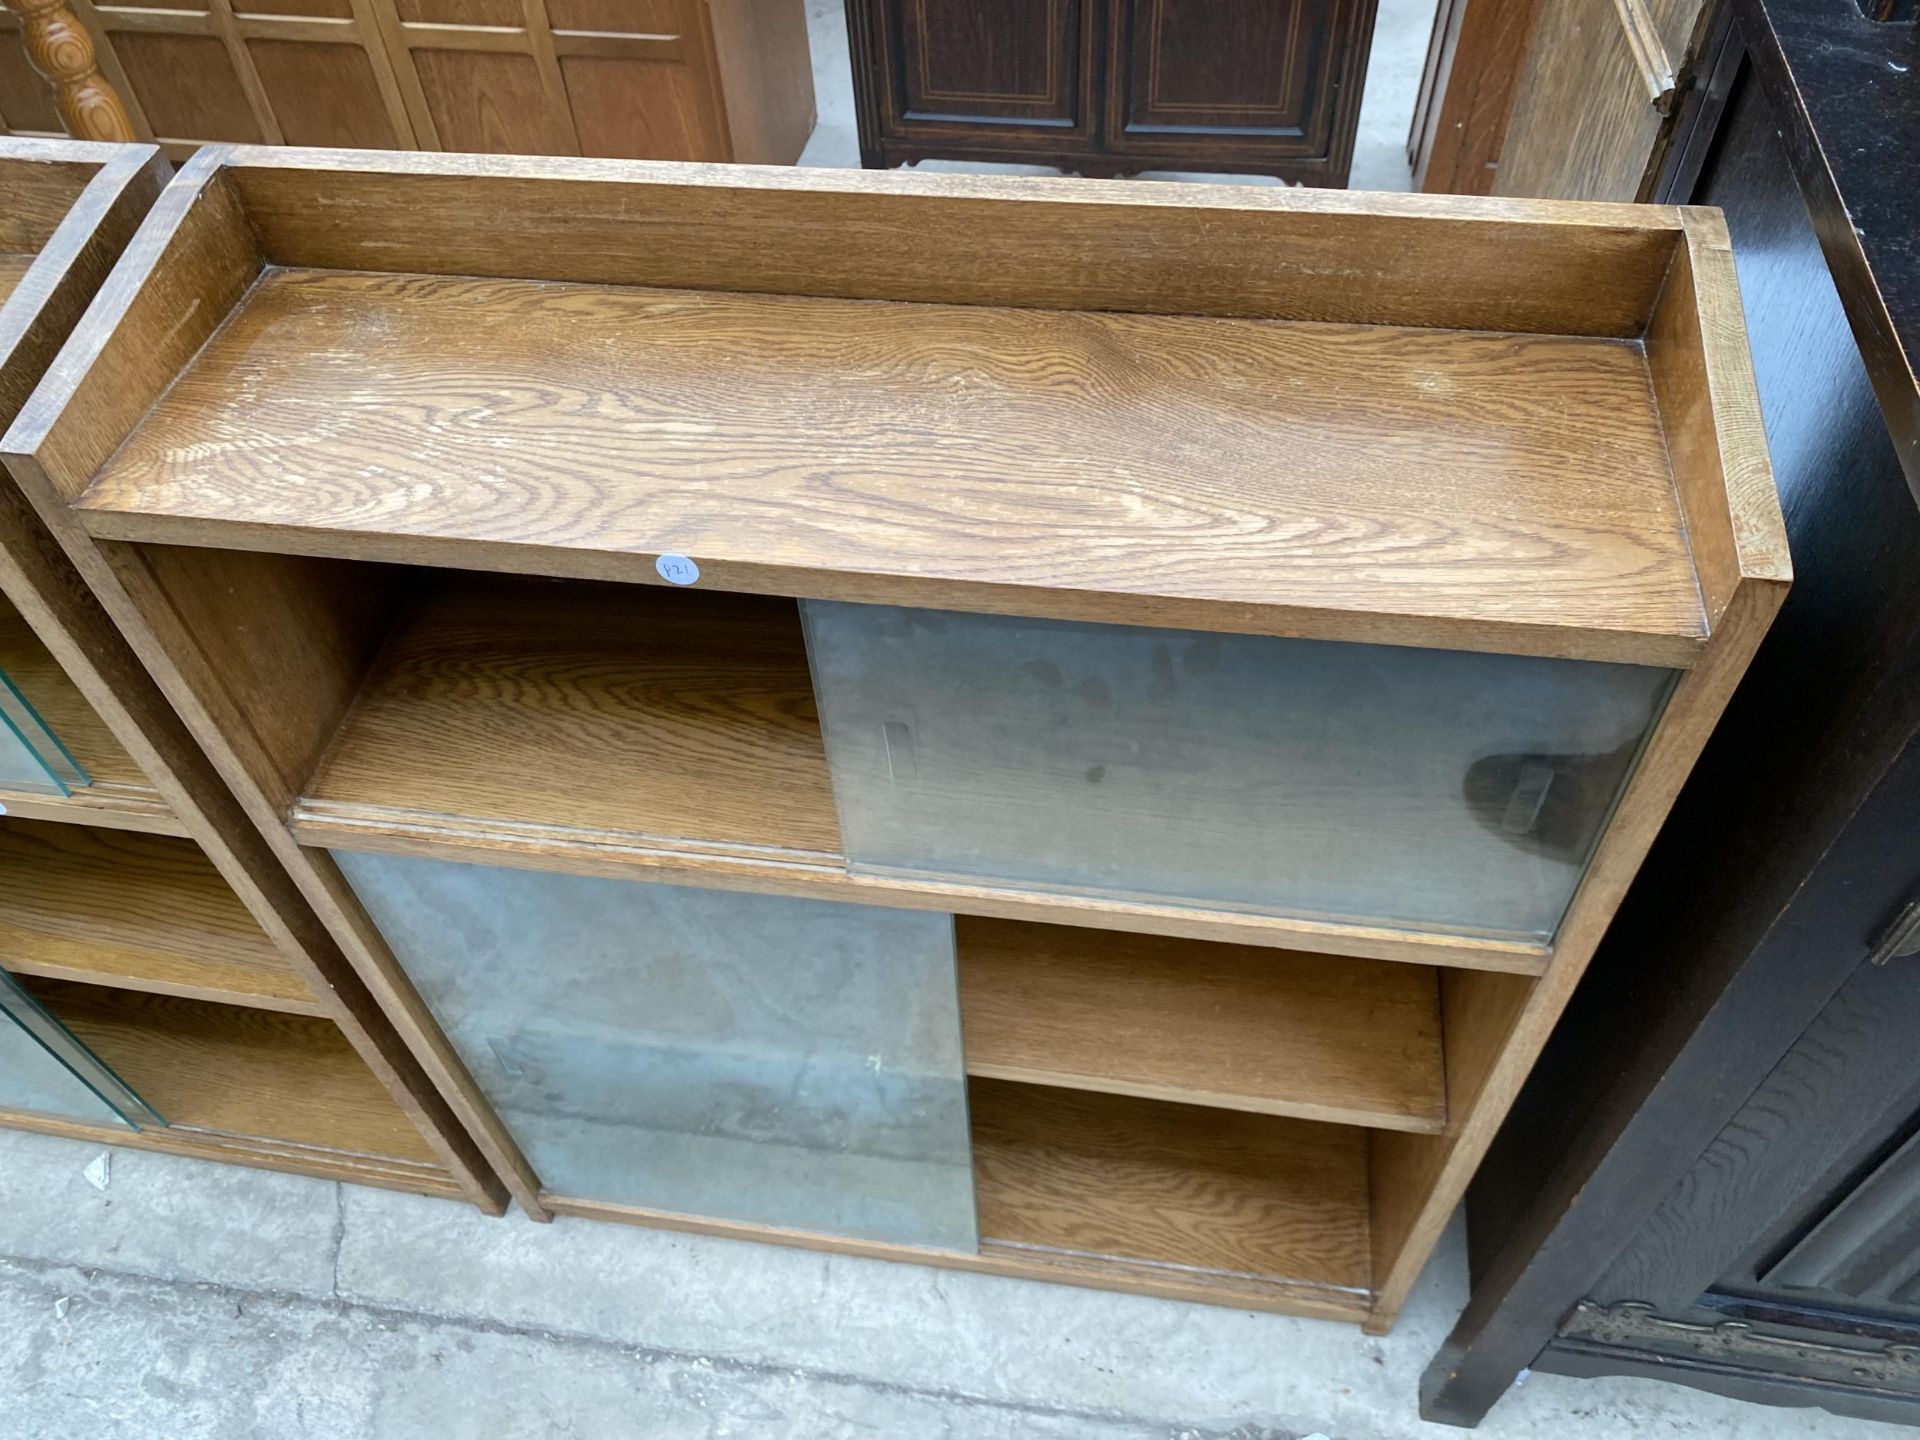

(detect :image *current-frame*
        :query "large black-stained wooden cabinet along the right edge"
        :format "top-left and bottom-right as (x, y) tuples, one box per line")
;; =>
(1425, 0), (1920, 1423)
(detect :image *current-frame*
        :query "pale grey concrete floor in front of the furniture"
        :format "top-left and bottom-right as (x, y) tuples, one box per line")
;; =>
(0, 1131), (1905, 1440)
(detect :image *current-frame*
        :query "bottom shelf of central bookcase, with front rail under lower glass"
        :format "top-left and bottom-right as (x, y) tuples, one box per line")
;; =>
(541, 1081), (1369, 1321)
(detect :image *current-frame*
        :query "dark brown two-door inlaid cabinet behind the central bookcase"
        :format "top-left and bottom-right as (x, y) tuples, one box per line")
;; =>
(847, 0), (1373, 186)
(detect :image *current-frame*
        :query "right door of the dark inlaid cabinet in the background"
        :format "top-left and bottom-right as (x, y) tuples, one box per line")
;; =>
(1106, 0), (1373, 157)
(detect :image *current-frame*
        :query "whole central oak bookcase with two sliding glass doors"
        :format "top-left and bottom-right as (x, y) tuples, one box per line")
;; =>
(6, 150), (1788, 1331)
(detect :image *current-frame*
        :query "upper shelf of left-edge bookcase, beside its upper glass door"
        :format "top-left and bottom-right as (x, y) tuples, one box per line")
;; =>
(0, 595), (184, 835)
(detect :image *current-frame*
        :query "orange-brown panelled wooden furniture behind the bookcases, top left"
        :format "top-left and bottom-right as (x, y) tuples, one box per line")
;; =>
(0, 0), (814, 165)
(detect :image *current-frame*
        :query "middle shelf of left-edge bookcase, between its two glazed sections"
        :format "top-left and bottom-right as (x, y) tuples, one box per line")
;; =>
(0, 820), (321, 1016)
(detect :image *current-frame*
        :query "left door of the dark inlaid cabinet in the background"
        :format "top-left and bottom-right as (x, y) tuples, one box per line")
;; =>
(876, 0), (1098, 148)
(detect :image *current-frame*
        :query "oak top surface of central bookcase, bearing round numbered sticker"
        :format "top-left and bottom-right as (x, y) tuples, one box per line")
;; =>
(79, 271), (1705, 664)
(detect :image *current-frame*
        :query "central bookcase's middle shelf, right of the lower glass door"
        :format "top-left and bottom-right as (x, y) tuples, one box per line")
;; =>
(958, 918), (1446, 1135)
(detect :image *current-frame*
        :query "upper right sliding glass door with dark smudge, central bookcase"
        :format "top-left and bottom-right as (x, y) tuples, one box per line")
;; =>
(803, 601), (1670, 939)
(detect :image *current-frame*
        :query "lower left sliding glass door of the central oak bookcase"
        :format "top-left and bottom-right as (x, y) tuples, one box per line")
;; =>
(334, 851), (977, 1250)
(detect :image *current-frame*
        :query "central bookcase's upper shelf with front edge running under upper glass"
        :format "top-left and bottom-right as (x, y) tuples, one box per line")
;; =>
(290, 572), (1546, 975)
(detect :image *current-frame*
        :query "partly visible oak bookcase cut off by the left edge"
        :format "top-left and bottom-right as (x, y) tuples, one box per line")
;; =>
(0, 138), (505, 1212)
